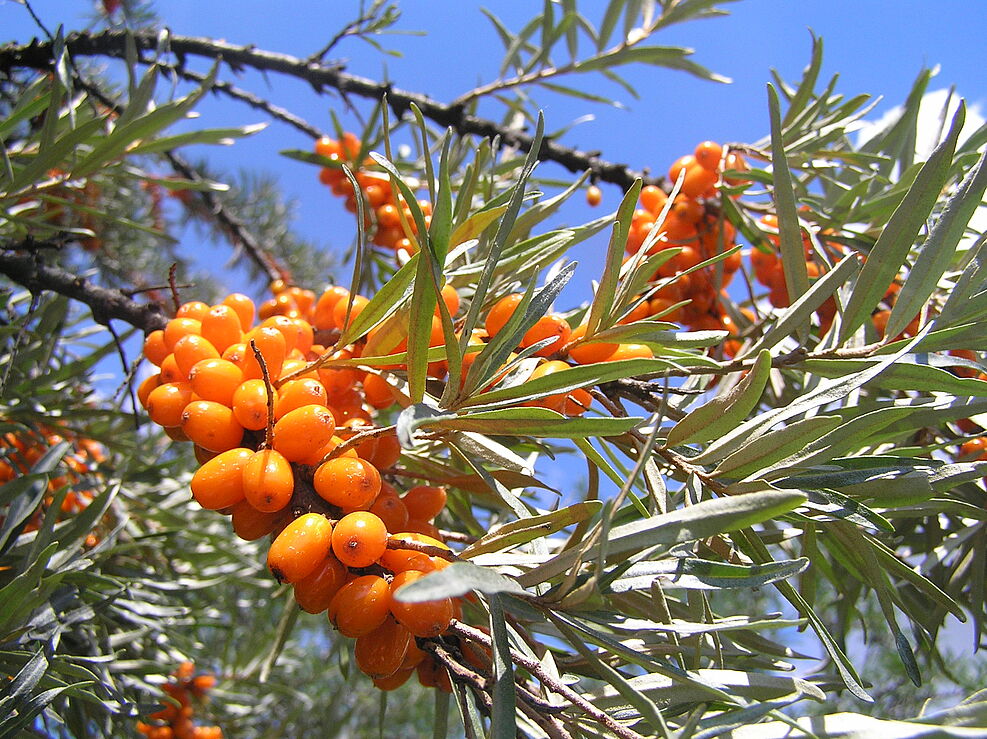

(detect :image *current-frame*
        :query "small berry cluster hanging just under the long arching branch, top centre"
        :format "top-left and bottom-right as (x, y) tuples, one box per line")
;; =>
(315, 132), (432, 256)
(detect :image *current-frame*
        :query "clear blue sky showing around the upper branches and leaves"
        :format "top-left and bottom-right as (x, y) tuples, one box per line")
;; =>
(7, 0), (987, 287)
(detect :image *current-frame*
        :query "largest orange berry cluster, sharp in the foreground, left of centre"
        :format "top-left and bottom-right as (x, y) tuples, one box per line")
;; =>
(138, 285), (476, 689)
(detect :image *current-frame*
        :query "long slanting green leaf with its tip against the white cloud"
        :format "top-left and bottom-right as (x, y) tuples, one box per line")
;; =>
(840, 103), (966, 343)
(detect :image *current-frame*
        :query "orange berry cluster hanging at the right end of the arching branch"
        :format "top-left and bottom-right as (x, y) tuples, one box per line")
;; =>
(626, 141), (747, 342)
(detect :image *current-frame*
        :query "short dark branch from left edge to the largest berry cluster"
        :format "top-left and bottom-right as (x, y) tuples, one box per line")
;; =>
(0, 244), (168, 333)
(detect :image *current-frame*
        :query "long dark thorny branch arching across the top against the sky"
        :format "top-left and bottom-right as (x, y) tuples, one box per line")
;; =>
(0, 31), (663, 189)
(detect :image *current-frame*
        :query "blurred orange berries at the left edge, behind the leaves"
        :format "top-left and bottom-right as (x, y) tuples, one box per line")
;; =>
(0, 428), (106, 546)
